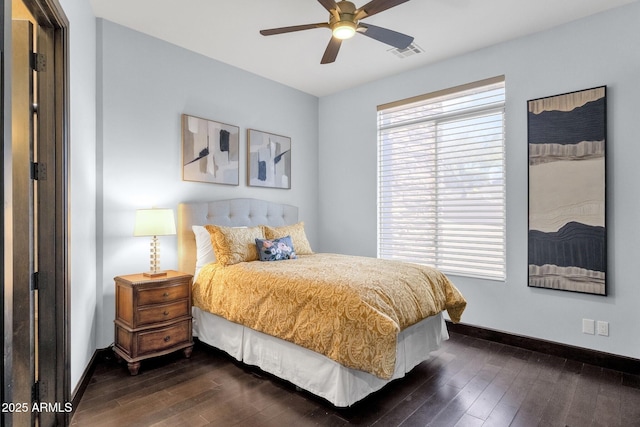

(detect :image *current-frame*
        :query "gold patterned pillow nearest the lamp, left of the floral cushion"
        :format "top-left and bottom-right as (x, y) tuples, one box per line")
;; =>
(204, 225), (265, 265)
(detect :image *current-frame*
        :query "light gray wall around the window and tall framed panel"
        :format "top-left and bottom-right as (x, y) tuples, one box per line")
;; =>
(318, 3), (640, 358)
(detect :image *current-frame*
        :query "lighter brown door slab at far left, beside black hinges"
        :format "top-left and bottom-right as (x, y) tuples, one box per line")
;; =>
(10, 20), (36, 426)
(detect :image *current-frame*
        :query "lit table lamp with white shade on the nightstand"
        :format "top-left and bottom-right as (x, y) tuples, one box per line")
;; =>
(133, 208), (176, 277)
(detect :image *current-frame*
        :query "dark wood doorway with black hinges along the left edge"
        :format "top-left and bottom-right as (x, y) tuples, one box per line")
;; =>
(7, 0), (72, 426)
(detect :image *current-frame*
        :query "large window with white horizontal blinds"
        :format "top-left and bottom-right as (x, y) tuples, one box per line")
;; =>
(378, 76), (505, 280)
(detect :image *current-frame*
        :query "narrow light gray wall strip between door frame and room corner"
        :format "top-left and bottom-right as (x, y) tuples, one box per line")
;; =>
(60, 0), (96, 393)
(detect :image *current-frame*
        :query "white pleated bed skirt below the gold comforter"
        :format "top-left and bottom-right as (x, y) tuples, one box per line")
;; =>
(193, 307), (449, 407)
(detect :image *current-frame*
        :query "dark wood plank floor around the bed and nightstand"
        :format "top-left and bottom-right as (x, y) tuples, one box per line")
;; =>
(72, 333), (640, 427)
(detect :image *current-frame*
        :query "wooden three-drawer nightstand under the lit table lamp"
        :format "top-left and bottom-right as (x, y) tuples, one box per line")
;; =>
(113, 270), (193, 375)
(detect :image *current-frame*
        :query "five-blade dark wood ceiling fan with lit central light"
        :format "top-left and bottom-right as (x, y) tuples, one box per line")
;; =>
(260, 0), (413, 64)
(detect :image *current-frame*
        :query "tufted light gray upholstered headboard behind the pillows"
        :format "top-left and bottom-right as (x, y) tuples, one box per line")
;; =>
(178, 199), (298, 274)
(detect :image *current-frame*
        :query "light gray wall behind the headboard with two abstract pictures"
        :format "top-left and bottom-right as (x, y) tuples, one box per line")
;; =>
(97, 19), (318, 348)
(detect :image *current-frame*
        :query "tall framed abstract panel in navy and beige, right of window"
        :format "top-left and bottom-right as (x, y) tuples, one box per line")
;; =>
(527, 86), (607, 295)
